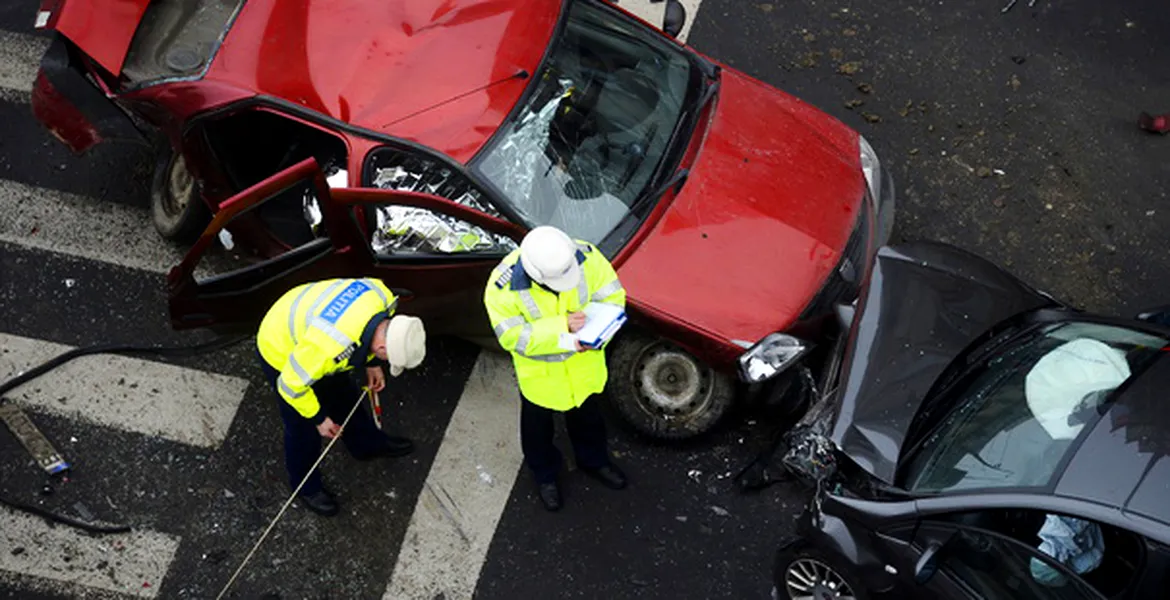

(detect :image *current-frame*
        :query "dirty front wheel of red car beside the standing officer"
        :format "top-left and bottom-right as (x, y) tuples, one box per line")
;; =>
(606, 329), (735, 441)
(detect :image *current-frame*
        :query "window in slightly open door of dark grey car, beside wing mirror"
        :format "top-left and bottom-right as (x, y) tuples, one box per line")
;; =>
(940, 527), (1103, 600)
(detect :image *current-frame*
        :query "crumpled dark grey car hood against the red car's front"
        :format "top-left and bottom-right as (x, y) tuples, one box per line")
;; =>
(831, 242), (1057, 484)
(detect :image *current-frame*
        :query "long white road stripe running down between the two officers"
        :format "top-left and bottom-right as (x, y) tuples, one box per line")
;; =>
(383, 352), (522, 600)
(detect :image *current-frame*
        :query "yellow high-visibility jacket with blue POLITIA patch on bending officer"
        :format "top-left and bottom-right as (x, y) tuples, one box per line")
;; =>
(256, 278), (398, 425)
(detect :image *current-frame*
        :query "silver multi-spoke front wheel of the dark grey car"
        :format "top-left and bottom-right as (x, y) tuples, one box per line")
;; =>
(773, 547), (867, 600)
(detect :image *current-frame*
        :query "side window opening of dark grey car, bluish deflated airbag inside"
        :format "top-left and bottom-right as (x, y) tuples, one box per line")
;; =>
(941, 509), (1145, 598)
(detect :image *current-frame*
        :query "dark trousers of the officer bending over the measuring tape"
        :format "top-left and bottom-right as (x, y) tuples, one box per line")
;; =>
(260, 358), (386, 496)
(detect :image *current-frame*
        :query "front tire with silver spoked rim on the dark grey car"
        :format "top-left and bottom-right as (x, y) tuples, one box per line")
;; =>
(772, 543), (869, 600)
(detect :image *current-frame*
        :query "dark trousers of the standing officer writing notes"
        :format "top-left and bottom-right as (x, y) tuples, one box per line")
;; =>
(519, 396), (610, 483)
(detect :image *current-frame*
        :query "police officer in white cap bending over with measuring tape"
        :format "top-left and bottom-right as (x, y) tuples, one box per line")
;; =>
(256, 280), (426, 516)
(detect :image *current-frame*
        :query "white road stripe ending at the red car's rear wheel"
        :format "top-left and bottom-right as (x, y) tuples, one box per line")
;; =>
(0, 180), (183, 273)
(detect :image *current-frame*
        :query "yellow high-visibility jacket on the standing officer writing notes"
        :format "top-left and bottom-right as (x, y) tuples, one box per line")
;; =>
(483, 241), (626, 411)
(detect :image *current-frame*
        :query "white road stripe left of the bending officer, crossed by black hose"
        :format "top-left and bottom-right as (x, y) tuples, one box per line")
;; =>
(0, 333), (248, 448)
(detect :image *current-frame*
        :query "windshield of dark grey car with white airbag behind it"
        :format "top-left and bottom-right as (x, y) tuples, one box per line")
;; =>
(903, 322), (1166, 492)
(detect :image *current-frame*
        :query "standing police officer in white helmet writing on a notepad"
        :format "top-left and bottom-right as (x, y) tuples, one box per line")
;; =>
(483, 227), (626, 510)
